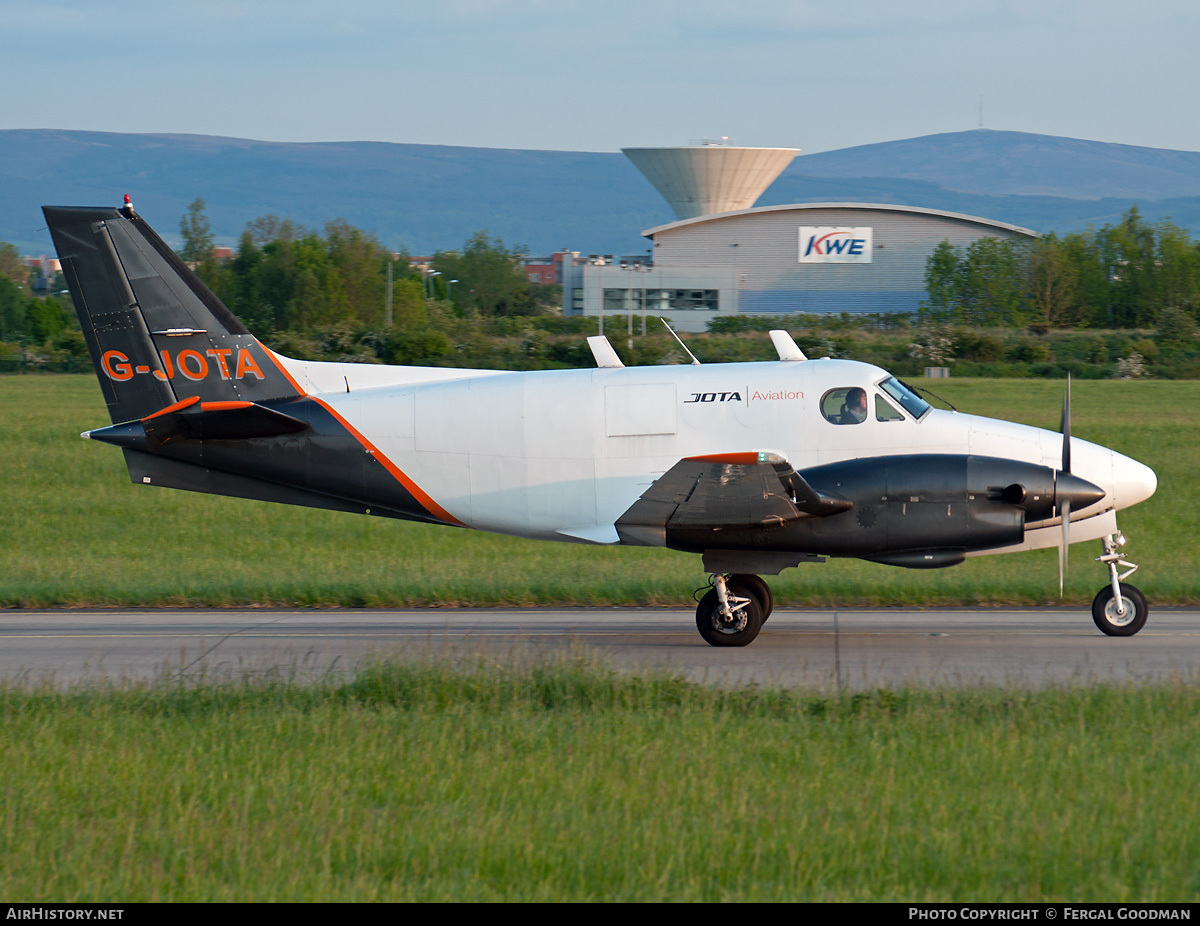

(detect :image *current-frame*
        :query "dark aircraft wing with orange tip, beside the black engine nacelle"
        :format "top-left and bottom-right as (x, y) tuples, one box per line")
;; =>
(616, 451), (852, 546)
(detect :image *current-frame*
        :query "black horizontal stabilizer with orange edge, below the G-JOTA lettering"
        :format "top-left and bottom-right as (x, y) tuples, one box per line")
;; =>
(84, 397), (312, 451)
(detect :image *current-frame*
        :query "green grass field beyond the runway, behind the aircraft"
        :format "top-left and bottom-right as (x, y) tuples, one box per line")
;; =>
(0, 375), (1200, 607)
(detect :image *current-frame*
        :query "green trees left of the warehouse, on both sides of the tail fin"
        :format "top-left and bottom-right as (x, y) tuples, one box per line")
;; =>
(0, 198), (562, 366)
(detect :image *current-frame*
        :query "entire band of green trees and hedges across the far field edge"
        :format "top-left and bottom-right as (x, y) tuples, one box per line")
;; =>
(7, 199), (1200, 378)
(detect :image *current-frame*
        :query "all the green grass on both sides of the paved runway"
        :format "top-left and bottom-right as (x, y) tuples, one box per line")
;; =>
(0, 377), (1200, 902)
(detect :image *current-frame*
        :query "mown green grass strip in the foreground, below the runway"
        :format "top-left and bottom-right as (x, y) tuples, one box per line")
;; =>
(0, 663), (1200, 902)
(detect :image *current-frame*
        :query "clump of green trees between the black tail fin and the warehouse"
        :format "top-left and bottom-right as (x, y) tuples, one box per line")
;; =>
(171, 198), (558, 363)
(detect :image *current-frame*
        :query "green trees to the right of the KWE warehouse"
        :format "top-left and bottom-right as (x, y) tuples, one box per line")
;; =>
(920, 206), (1200, 330)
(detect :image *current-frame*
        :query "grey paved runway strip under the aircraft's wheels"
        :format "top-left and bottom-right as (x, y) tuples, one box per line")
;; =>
(0, 608), (1200, 690)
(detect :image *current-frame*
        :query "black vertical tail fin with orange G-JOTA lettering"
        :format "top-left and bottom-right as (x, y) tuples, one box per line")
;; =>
(42, 206), (301, 422)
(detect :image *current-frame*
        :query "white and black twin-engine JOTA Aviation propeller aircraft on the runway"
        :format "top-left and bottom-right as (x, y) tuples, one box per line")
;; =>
(44, 202), (1157, 647)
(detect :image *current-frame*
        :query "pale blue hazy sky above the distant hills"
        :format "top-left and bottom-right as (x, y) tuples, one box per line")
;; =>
(0, 0), (1200, 152)
